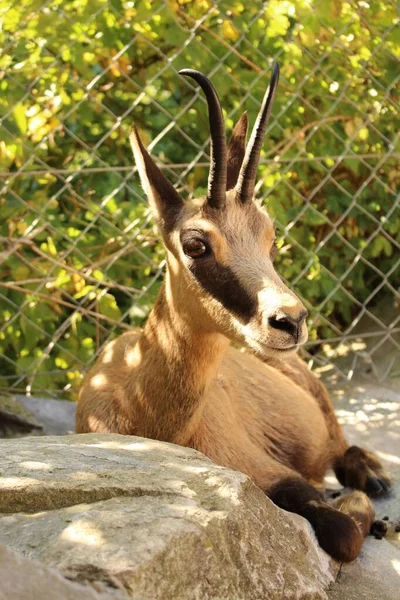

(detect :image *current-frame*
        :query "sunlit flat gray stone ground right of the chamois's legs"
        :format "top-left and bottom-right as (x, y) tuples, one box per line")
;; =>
(327, 379), (400, 600)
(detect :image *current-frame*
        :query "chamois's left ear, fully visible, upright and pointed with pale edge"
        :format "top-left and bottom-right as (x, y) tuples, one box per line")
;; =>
(129, 125), (183, 231)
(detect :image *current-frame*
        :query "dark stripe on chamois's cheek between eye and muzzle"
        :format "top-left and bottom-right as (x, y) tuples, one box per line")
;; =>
(189, 257), (257, 323)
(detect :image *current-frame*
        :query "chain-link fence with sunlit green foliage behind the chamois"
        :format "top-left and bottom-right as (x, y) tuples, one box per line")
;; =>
(0, 0), (400, 398)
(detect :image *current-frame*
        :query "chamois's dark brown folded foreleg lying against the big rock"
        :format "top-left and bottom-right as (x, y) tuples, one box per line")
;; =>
(266, 477), (374, 562)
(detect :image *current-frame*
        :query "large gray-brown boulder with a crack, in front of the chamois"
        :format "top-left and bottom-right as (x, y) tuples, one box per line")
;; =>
(0, 434), (332, 600)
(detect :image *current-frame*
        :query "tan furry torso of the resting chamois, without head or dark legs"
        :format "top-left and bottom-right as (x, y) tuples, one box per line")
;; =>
(77, 290), (334, 489)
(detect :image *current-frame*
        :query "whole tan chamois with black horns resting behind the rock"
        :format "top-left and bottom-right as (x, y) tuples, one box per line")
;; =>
(77, 63), (390, 561)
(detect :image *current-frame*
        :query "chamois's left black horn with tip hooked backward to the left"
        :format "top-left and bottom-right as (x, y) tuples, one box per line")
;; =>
(179, 69), (226, 208)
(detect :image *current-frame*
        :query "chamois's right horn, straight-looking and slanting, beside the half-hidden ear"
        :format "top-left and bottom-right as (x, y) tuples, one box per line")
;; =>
(236, 62), (279, 204)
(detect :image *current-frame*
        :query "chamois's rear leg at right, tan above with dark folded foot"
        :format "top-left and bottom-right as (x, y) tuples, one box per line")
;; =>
(273, 356), (391, 496)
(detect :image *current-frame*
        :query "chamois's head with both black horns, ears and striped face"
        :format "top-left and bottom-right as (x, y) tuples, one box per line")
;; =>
(130, 64), (307, 355)
